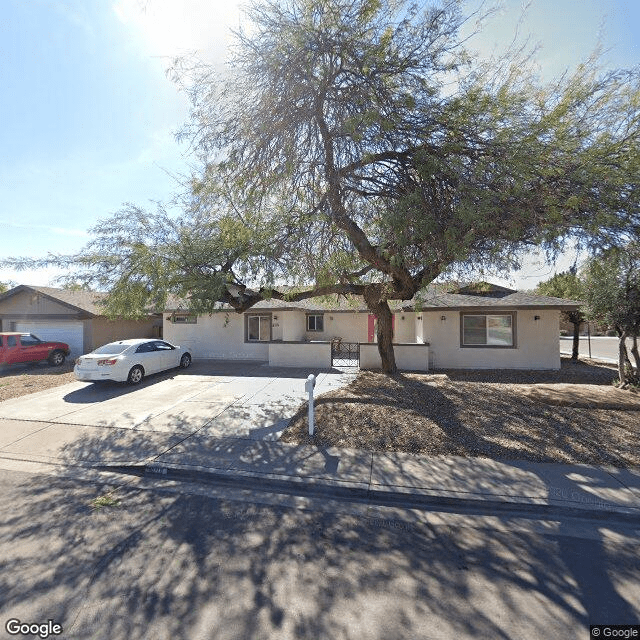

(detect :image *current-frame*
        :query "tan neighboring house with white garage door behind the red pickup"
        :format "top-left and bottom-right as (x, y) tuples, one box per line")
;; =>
(0, 285), (162, 357)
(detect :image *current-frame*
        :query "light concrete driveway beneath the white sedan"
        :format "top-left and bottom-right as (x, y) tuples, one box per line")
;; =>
(0, 360), (355, 464)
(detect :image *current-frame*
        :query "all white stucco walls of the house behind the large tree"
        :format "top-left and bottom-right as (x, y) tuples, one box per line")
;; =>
(163, 309), (560, 370)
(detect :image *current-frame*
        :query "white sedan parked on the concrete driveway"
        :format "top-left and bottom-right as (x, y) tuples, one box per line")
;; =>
(73, 338), (191, 384)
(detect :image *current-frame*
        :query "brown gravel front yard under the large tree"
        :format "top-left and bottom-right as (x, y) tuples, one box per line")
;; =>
(281, 359), (640, 467)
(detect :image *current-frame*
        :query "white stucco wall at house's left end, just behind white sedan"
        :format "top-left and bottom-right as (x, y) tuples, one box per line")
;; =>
(163, 312), (269, 362)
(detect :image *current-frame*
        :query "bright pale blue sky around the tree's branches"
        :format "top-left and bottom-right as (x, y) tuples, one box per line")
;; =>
(0, 0), (640, 288)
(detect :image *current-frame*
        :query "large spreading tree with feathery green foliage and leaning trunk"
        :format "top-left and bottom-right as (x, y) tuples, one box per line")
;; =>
(5, 0), (640, 372)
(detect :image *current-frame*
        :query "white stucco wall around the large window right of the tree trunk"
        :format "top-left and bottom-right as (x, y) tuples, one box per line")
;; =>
(422, 309), (560, 369)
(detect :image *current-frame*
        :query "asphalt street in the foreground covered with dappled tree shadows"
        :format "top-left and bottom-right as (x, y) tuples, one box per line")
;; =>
(0, 470), (640, 640)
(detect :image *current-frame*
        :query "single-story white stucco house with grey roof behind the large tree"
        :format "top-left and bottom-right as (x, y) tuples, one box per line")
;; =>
(163, 283), (578, 370)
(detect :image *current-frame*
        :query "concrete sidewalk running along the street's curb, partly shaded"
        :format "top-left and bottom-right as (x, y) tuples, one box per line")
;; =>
(0, 420), (640, 518)
